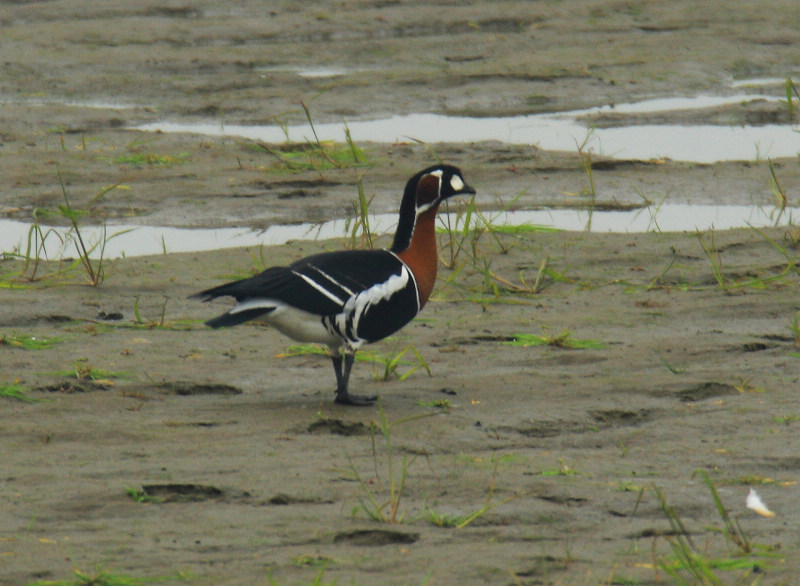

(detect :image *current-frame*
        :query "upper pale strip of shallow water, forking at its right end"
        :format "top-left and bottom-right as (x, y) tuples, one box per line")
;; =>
(137, 94), (800, 163)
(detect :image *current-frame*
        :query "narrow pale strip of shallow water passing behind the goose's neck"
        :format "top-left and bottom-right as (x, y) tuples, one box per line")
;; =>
(0, 204), (800, 259)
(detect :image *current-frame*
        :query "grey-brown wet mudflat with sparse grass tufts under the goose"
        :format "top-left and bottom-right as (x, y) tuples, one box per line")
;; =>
(0, 0), (800, 586)
